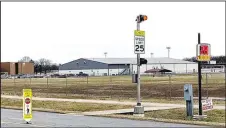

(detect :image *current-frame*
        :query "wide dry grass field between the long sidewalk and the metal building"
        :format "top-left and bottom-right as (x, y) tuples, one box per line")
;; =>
(1, 73), (225, 100)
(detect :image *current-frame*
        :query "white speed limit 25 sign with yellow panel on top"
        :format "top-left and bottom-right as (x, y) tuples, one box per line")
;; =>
(134, 30), (145, 54)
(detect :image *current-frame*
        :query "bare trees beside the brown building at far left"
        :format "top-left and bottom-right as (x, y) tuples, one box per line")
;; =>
(18, 56), (59, 74)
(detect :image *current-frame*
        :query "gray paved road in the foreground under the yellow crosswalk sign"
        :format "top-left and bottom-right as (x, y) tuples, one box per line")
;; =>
(1, 109), (205, 127)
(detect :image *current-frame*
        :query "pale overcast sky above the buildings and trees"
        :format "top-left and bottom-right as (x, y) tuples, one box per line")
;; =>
(1, 2), (225, 63)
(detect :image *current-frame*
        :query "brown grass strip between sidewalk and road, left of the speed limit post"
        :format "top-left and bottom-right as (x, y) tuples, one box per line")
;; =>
(1, 98), (133, 112)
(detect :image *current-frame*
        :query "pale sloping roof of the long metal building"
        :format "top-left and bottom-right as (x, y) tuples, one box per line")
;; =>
(83, 57), (196, 64)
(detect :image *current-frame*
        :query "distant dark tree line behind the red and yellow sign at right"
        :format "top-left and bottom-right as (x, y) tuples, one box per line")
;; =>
(183, 56), (226, 64)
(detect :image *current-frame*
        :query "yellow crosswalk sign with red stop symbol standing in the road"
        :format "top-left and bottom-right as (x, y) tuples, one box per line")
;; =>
(23, 89), (32, 123)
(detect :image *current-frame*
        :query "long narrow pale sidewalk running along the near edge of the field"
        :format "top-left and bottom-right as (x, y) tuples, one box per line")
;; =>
(1, 95), (225, 110)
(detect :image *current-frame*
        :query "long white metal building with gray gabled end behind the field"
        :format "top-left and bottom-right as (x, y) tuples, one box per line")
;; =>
(59, 57), (197, 76)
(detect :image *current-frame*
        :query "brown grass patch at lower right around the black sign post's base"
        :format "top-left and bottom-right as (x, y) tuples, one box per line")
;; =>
(102, 108), (225, 127)
